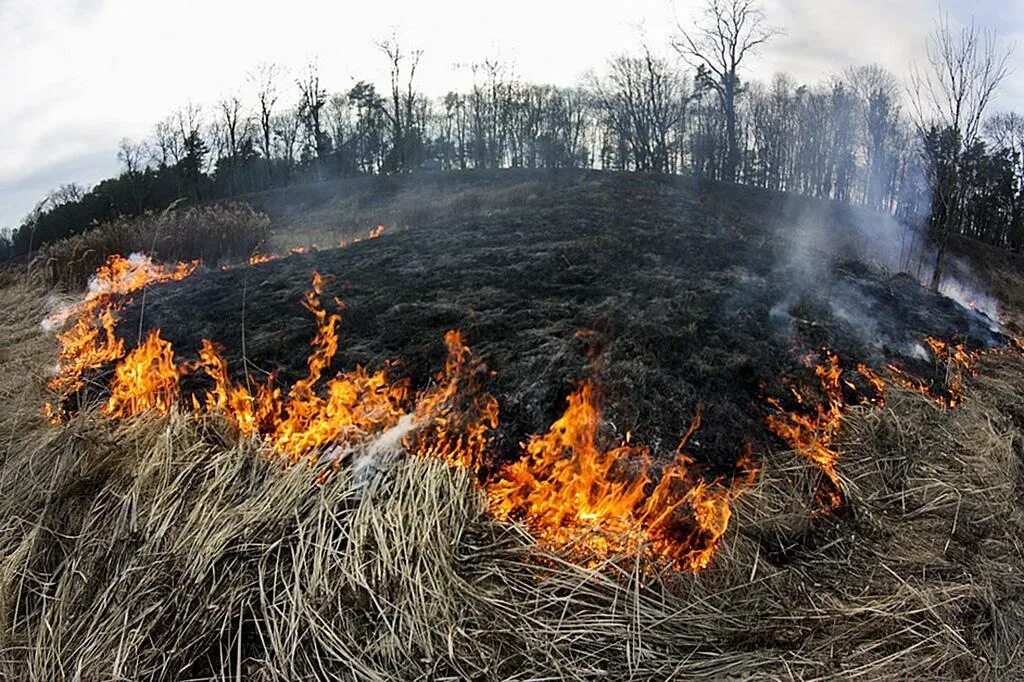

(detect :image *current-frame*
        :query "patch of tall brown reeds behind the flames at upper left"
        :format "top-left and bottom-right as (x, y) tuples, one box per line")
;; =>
(35, 202), (270, 291)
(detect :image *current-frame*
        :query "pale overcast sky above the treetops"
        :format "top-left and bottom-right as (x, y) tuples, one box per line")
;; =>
(0, 0), (1024, 226)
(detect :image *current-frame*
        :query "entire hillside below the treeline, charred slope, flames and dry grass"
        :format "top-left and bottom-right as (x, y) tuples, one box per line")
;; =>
(0, 171), (1024, 680)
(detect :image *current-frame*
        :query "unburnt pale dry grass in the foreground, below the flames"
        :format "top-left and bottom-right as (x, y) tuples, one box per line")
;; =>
(0, 272), (1024, 680)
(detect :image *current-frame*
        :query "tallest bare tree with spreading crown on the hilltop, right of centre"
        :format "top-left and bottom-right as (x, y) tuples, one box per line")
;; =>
(673, 0), (780, 181)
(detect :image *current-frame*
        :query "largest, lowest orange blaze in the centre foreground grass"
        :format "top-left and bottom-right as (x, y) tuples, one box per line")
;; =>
(487, 383), (756, 570)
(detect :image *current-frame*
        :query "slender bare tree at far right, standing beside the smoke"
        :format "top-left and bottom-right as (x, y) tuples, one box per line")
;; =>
(910, 13), (1013, 291)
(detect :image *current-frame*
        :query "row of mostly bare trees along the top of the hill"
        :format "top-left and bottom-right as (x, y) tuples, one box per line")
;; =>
(5, 0), (1024, 270)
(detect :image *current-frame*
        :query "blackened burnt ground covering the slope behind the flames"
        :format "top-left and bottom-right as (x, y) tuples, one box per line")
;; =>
(121, 172), (999, 464)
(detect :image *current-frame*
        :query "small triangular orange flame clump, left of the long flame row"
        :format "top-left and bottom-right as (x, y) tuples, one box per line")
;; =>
(103, 330), (181, 418)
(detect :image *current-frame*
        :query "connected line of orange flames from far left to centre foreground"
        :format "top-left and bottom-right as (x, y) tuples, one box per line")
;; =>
(47, 257), (757, 571)
